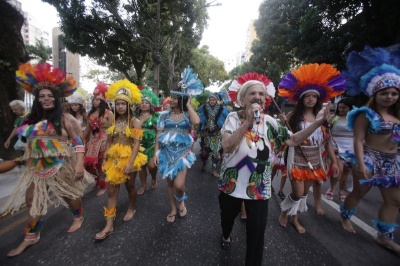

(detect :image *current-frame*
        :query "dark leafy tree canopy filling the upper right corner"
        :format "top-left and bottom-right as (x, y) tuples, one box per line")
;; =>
(250, 0), (400, 82)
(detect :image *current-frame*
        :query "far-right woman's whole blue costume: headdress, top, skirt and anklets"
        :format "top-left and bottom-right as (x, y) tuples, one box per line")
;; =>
(340, 46), (400, 240)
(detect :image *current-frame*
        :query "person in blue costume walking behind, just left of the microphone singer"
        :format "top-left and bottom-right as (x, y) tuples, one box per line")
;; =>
(197, 93), (230, 174)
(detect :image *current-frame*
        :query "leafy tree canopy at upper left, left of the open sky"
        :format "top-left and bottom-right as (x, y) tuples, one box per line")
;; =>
(43, 0), (206, 93)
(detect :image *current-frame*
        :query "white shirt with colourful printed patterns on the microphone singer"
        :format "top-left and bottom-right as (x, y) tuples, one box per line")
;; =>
(218, 112), (291, 200)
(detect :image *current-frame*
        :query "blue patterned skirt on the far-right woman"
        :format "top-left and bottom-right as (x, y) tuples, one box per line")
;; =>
(345, 146), (400, 188)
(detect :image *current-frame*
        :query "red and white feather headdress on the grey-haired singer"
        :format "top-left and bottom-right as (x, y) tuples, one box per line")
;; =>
(229, 73), (276, 107)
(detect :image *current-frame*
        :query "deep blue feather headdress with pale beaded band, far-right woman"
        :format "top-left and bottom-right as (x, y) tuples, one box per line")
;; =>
(343, 46), (400, 97)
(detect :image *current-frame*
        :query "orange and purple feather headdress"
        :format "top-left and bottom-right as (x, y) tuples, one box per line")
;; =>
(278, 64), (346, 103)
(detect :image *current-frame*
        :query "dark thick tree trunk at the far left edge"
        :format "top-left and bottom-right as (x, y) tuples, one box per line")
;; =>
(0, 0), (29, 159)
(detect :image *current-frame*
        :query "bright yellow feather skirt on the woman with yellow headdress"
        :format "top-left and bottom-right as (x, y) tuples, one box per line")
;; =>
(104, 143), (147, 185)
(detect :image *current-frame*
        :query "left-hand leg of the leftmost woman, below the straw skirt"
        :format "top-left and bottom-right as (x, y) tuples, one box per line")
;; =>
(7, 183), (43, 257)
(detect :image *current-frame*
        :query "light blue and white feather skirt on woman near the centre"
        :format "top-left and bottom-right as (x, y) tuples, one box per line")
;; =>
(158, 132), (196, 180)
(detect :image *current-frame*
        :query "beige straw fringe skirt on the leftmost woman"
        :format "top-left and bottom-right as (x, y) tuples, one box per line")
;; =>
(4, 143), (94, 217)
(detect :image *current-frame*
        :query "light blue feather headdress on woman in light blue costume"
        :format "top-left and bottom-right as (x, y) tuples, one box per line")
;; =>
(171, 66), (204, 97)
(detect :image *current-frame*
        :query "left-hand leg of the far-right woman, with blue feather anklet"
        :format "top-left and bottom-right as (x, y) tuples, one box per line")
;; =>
(340, 168), (371, 233)
